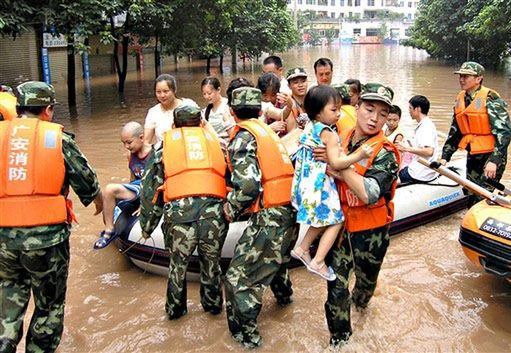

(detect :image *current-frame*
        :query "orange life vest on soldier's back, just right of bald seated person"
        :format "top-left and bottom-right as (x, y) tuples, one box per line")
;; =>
(162, 127), (227, 202)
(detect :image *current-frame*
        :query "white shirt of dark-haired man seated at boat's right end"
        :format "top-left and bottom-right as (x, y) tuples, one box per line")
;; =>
(408, 117), (438, 181)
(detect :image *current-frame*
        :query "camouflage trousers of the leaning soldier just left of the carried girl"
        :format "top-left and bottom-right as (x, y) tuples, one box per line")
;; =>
(225, 224), (298, 348)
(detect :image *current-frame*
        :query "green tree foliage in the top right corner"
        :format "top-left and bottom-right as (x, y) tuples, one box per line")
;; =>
(407, 0), (511, 65)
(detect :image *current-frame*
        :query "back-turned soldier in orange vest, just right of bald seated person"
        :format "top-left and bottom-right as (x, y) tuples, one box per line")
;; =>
(140, 104), (228, 320)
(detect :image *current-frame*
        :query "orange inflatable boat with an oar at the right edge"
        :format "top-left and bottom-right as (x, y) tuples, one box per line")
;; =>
(420, 158), (511, 281)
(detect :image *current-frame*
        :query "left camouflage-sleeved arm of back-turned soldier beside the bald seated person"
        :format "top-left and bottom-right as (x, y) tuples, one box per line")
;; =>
(139, 143), (165, 235)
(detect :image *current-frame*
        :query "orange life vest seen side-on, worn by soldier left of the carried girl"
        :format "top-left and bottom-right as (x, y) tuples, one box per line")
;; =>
(229, 119), (294, 213)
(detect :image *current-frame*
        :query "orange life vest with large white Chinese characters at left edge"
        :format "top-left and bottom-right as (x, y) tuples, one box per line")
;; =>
(0, 118), (68, 227)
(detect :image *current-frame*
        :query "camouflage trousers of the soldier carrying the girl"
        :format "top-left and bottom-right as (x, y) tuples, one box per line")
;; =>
(325, 226), (389, 346)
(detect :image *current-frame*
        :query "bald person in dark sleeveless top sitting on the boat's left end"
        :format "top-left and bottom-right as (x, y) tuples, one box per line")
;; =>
(94, 121), (151, 250)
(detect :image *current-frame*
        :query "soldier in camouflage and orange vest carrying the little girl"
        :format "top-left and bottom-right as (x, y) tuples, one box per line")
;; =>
(315, 83), (399, 346)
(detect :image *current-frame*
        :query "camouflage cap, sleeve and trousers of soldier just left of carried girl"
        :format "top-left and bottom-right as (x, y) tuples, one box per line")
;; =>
(224, 83), (297, 348)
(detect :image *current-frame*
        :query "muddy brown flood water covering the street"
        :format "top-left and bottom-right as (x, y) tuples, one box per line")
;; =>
(20, 45), (511, 353)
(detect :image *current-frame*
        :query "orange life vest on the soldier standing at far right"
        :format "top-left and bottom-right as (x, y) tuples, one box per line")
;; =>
(454, 86), (495, 154)
